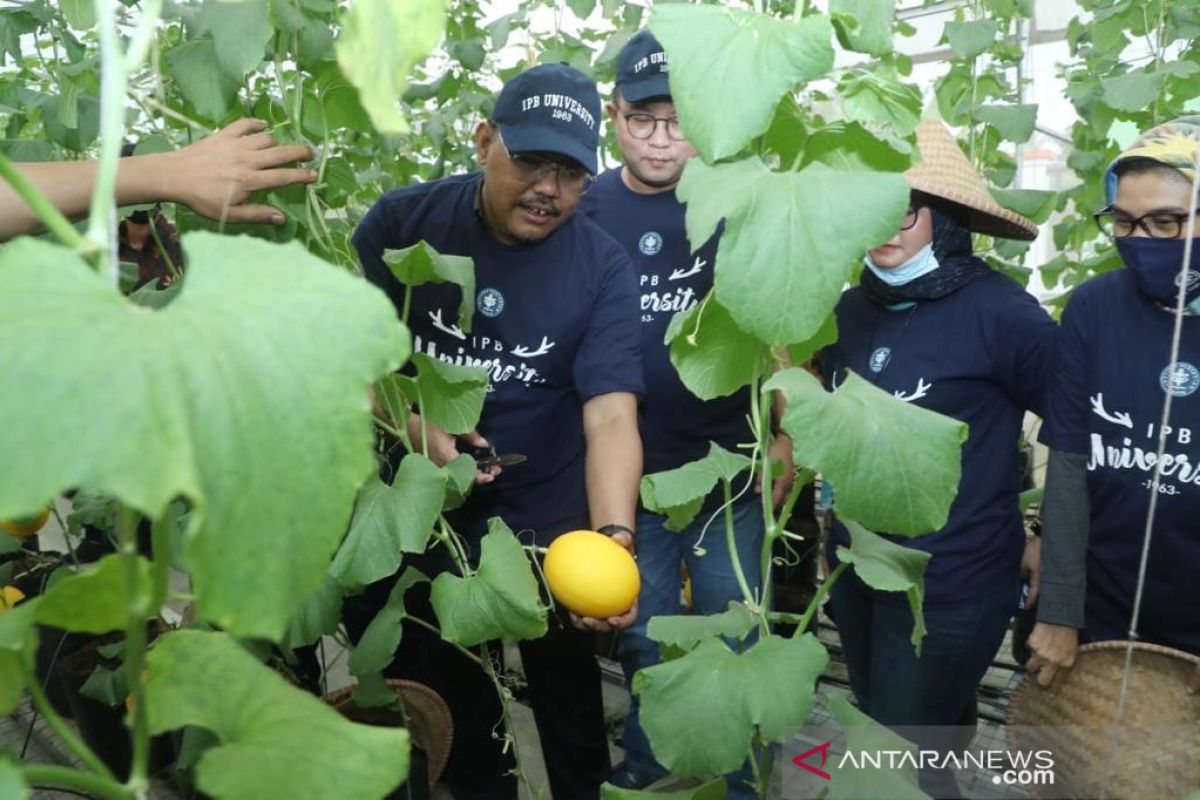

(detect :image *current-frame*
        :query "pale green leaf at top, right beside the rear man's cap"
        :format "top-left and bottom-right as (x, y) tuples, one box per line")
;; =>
(650, 4), (833, 163)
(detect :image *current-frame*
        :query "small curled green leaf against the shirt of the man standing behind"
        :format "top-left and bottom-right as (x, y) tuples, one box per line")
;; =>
(666, 293), (767, 399)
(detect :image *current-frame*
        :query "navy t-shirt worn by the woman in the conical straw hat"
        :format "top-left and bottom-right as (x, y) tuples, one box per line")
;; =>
(812, 272), (1055, 608)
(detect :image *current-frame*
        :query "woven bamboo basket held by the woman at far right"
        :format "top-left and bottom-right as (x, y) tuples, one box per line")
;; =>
(1007, 642), (1200, 800)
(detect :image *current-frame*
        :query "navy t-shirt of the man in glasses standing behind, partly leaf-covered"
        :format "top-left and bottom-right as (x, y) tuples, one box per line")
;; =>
(580, 168), (751, 475)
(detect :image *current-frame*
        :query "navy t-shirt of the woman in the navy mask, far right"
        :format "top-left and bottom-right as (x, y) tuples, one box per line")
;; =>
(1040, 270), (1200, 654)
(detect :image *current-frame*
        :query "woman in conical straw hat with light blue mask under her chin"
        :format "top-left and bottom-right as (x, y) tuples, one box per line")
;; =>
(822, 120), (1055, 798)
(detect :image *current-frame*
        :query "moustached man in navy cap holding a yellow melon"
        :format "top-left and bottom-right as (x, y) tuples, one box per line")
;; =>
(348, 64), (642, 800)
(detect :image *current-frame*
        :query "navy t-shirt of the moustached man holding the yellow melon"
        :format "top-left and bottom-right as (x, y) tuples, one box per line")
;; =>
(354, 174), (642, 543)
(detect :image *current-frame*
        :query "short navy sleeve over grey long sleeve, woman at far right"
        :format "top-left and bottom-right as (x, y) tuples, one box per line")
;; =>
(1039, 290), (1091, 453)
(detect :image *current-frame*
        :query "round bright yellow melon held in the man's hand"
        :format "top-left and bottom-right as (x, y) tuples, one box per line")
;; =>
(542, 530), (641, 619)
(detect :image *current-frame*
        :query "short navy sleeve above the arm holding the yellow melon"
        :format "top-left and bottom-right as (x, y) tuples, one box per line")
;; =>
(575, 242), (644, 403)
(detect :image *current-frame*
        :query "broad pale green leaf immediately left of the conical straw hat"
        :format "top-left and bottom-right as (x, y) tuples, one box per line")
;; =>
(678, 158), (908, 347)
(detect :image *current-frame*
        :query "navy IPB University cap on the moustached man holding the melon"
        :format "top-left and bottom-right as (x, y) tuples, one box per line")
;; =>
(492, 64), (600, 175)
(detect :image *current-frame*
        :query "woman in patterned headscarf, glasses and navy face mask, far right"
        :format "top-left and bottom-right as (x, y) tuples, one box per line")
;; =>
(1028, 116), (1200, 686)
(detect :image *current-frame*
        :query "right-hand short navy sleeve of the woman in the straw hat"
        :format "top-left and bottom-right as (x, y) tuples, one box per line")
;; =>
(992, 291), (1056, 414)
